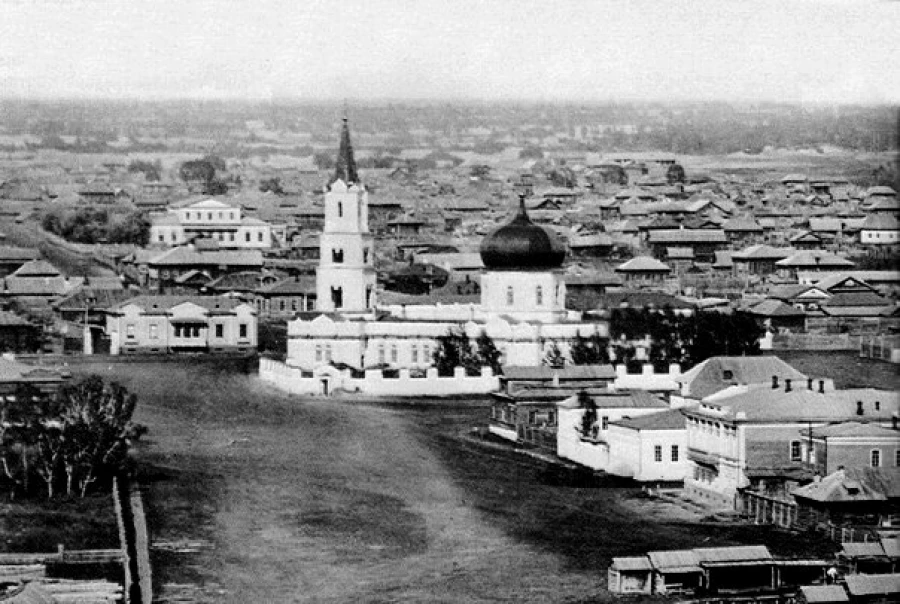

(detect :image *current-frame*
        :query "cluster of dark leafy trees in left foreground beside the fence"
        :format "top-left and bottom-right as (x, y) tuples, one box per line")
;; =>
(0, 376), (146, 499)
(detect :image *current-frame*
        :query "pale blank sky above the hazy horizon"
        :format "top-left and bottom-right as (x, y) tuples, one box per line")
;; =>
(0, 0), (900, 103)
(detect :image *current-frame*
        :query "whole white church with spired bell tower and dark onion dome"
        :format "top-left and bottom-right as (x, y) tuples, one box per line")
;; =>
(286, 119), (607, 371)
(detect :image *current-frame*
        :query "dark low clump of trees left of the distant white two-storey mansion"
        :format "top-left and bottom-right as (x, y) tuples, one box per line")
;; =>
(41, 206), (150, 245)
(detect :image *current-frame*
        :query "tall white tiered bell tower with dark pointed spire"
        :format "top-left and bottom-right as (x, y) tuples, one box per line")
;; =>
(316, 117), (375, 314)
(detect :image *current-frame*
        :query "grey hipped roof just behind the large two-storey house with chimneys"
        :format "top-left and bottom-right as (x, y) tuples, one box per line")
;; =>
(677, 355), (806, 398)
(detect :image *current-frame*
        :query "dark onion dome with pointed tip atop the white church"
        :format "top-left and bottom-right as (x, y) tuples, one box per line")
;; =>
(480, 196), (566, 271)
